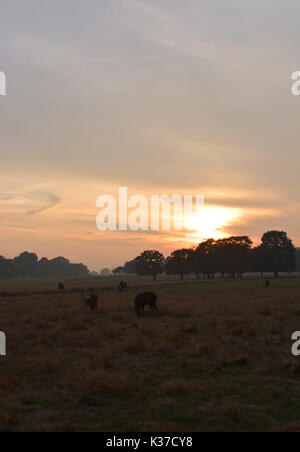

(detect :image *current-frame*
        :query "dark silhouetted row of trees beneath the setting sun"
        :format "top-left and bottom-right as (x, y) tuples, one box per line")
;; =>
(113, 231), (298, 281)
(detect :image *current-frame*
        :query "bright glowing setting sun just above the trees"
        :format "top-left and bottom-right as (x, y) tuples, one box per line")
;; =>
(186, 206), (242, 242)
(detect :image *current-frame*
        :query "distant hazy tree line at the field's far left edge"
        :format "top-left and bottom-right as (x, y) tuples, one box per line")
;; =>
(0, 251), (89, 278)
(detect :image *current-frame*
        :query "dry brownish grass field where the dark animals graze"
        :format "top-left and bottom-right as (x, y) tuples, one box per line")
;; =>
(0, 279), (300, 432)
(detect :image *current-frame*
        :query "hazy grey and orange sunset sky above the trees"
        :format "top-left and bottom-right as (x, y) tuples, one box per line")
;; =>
(0, 0), (300, 271)
